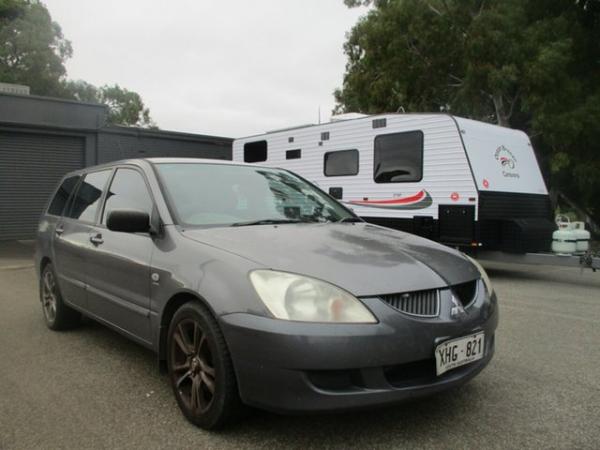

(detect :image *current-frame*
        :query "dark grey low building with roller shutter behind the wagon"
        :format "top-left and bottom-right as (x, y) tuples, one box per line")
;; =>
(0, 93), (232, 240)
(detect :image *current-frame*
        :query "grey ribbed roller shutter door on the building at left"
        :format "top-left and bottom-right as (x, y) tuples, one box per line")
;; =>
(0, 131), (85, 240)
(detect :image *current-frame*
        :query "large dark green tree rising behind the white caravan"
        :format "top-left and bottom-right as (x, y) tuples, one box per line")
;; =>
(334, 0), (600, 225)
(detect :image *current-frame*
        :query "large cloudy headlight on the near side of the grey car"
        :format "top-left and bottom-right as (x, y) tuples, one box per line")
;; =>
(250, 270), (377, 323)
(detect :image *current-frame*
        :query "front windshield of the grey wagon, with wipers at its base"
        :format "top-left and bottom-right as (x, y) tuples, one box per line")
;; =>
(156, 163), (356, 226)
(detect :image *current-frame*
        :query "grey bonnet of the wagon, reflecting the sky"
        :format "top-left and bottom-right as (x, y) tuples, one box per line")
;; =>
(183, 223), (479, 296)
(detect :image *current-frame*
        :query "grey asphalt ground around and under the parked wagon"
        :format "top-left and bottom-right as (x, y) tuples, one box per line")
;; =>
(0, 247), (600, 449)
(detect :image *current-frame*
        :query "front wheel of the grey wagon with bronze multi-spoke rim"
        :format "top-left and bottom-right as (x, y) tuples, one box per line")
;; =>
(167, 301), (243, 430)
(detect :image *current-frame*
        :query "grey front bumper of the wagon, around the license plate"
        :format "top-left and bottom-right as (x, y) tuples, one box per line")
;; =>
(221, 290), (498, 413)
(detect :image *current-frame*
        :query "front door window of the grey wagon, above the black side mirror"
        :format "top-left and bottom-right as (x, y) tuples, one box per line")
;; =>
(102, 169), (152, 223)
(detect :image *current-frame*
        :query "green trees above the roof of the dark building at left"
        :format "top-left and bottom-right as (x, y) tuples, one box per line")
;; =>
(0, 0), (156, 128)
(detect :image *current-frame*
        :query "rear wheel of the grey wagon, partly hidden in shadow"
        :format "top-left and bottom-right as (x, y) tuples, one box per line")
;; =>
(40, 263), (81, 331)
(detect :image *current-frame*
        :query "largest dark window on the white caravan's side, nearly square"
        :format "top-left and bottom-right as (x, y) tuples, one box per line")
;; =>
(373, 131), (423, 183)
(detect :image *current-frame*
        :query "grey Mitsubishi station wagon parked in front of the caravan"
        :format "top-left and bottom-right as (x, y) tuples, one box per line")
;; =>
(36, 158), (498, 429)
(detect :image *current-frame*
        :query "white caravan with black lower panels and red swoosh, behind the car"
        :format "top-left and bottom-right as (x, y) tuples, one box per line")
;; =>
(233, 114), (555, 253)
